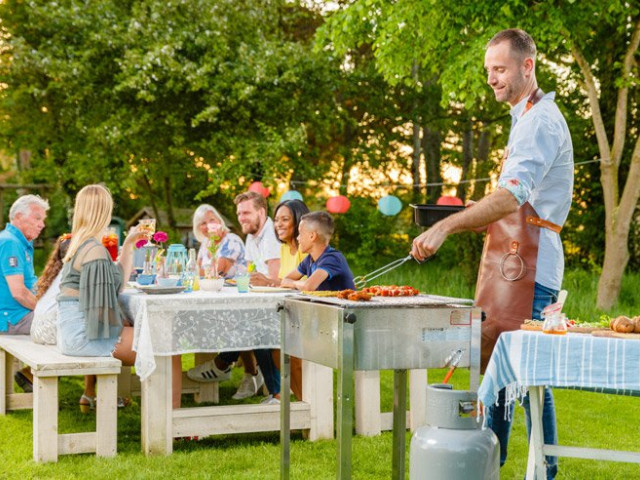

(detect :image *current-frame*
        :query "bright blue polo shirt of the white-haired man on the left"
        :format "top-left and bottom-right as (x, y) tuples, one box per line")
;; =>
(0, 224), (37, 332)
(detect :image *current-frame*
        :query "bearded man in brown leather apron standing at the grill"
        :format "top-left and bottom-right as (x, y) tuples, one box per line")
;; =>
(412, 29), (573, 479)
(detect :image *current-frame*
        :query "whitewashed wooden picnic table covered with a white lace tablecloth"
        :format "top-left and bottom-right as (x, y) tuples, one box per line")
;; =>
(120, 287), (333, 455)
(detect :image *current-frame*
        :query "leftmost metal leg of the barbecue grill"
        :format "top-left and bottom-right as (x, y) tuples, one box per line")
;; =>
(280, 308), (291, 480)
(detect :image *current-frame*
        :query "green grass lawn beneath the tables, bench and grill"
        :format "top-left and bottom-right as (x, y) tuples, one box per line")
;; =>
(0, 261), (640, 480)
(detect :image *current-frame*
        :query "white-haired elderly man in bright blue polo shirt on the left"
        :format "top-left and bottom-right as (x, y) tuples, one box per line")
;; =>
(0, 195), (49, 391)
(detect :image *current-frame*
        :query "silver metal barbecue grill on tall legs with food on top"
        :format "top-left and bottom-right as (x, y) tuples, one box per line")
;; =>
(281, 295), (481, 479)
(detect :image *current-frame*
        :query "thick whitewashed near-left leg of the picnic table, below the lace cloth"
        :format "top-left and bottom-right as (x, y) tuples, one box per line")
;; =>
(140, 356), (173, 455)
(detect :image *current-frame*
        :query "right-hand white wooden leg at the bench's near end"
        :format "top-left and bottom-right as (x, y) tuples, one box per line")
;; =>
(96, 374), (118, 457)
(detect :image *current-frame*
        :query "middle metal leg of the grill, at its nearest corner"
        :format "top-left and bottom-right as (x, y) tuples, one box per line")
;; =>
(337, 321), (354, 480)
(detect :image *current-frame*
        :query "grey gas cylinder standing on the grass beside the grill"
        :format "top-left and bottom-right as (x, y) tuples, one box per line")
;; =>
(409, 384), (500, 480)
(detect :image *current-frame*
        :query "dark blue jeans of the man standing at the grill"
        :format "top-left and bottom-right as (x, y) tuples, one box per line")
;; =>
(487, 283), (558, 480)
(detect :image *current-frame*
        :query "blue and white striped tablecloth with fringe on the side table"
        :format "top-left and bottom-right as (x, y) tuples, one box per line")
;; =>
(478, 330), (640, 406)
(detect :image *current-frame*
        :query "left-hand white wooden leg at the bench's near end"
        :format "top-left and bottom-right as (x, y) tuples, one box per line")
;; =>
(33, 376), (58, 462)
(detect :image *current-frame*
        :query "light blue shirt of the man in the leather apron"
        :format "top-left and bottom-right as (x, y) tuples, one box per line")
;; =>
(498, 92), (573, 290)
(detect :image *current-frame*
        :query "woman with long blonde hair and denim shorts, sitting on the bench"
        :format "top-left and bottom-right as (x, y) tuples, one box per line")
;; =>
(57, 185), (143, 412)
